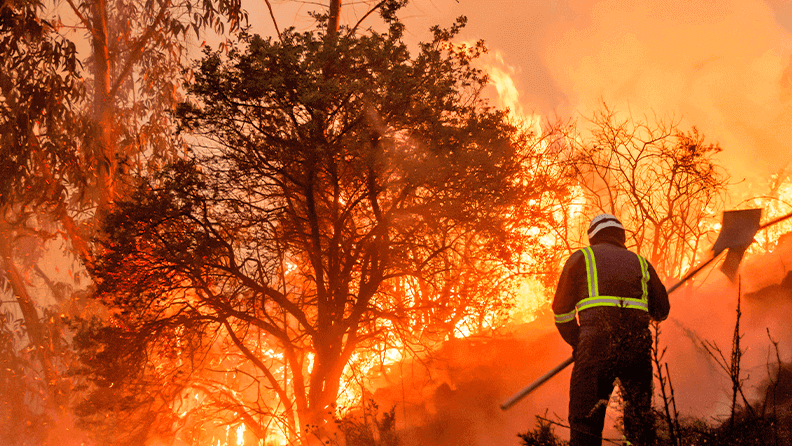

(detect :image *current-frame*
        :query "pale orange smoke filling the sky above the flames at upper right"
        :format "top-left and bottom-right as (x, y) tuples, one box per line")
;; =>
(407, 0), (792, 190)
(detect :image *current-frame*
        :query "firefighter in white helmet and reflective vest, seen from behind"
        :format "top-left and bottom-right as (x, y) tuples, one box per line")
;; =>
(553, 214), (670, 446)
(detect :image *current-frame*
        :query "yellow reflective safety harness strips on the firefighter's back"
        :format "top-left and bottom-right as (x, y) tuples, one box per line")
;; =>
(555, 246), (649, 324)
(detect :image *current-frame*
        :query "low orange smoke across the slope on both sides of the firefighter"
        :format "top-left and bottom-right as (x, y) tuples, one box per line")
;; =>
(366, 237), (792, 446)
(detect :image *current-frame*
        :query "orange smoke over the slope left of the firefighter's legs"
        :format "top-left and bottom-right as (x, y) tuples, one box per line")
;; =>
(374, 311), (571, 446)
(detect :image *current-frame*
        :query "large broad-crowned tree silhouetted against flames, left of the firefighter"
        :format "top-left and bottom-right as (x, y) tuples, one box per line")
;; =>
(86, 18), (568, 444)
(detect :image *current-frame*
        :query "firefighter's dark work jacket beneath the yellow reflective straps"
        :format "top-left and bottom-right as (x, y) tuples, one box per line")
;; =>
(553, 237), (670, 347)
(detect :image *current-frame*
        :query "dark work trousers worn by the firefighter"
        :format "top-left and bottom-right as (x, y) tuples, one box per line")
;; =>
(569, 307), (655, 446)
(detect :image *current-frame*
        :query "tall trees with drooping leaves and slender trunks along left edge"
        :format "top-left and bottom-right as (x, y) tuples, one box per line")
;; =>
(0, 0), (245, 444)
